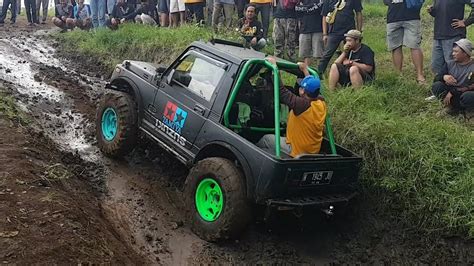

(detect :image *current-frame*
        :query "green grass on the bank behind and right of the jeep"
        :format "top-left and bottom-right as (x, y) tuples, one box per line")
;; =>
(58, 1), (474, 238)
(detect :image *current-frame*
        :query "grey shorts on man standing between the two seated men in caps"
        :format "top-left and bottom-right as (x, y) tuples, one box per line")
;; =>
(387, 19), (421, 51)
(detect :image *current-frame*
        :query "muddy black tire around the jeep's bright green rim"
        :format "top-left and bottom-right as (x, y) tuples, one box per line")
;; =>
(185, 157), (252, 242)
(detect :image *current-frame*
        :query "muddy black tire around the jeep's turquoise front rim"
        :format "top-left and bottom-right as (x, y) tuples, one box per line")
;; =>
(96, 92), (138, 158)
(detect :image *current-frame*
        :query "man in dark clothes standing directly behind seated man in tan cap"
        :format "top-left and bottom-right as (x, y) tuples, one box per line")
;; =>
(318, 0), (362, 75)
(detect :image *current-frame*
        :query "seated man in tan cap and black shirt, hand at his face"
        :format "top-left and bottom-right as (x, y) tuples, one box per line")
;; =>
(329, 30), (375, 90)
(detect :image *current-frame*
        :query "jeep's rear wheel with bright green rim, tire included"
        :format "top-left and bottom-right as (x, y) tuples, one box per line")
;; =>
(185, 157), (252, 242)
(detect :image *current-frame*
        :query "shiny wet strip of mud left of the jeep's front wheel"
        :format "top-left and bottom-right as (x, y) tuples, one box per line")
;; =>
(0, 37), (97, 161)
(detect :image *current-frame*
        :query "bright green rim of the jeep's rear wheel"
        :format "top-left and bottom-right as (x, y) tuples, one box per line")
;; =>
(196, 178), (224, 222)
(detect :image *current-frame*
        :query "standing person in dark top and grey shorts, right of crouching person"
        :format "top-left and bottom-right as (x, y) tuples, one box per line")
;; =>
(295, 0), (324, 65)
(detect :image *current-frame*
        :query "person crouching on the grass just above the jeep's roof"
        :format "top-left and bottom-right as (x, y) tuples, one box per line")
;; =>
(237, 4), (267, 51)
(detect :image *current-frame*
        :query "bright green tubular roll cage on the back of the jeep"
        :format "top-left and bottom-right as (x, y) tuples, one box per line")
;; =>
(224, 59), (337, 158)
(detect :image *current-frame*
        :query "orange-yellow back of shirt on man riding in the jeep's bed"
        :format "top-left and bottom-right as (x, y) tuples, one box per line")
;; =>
(286, 100), (326, 157)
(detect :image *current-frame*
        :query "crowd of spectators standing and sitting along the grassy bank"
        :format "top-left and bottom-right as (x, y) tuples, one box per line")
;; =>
(0, 0), (474, 116)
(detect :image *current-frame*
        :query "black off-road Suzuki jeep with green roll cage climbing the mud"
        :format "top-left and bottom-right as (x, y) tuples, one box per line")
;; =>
(96, 41), (361, 241)
